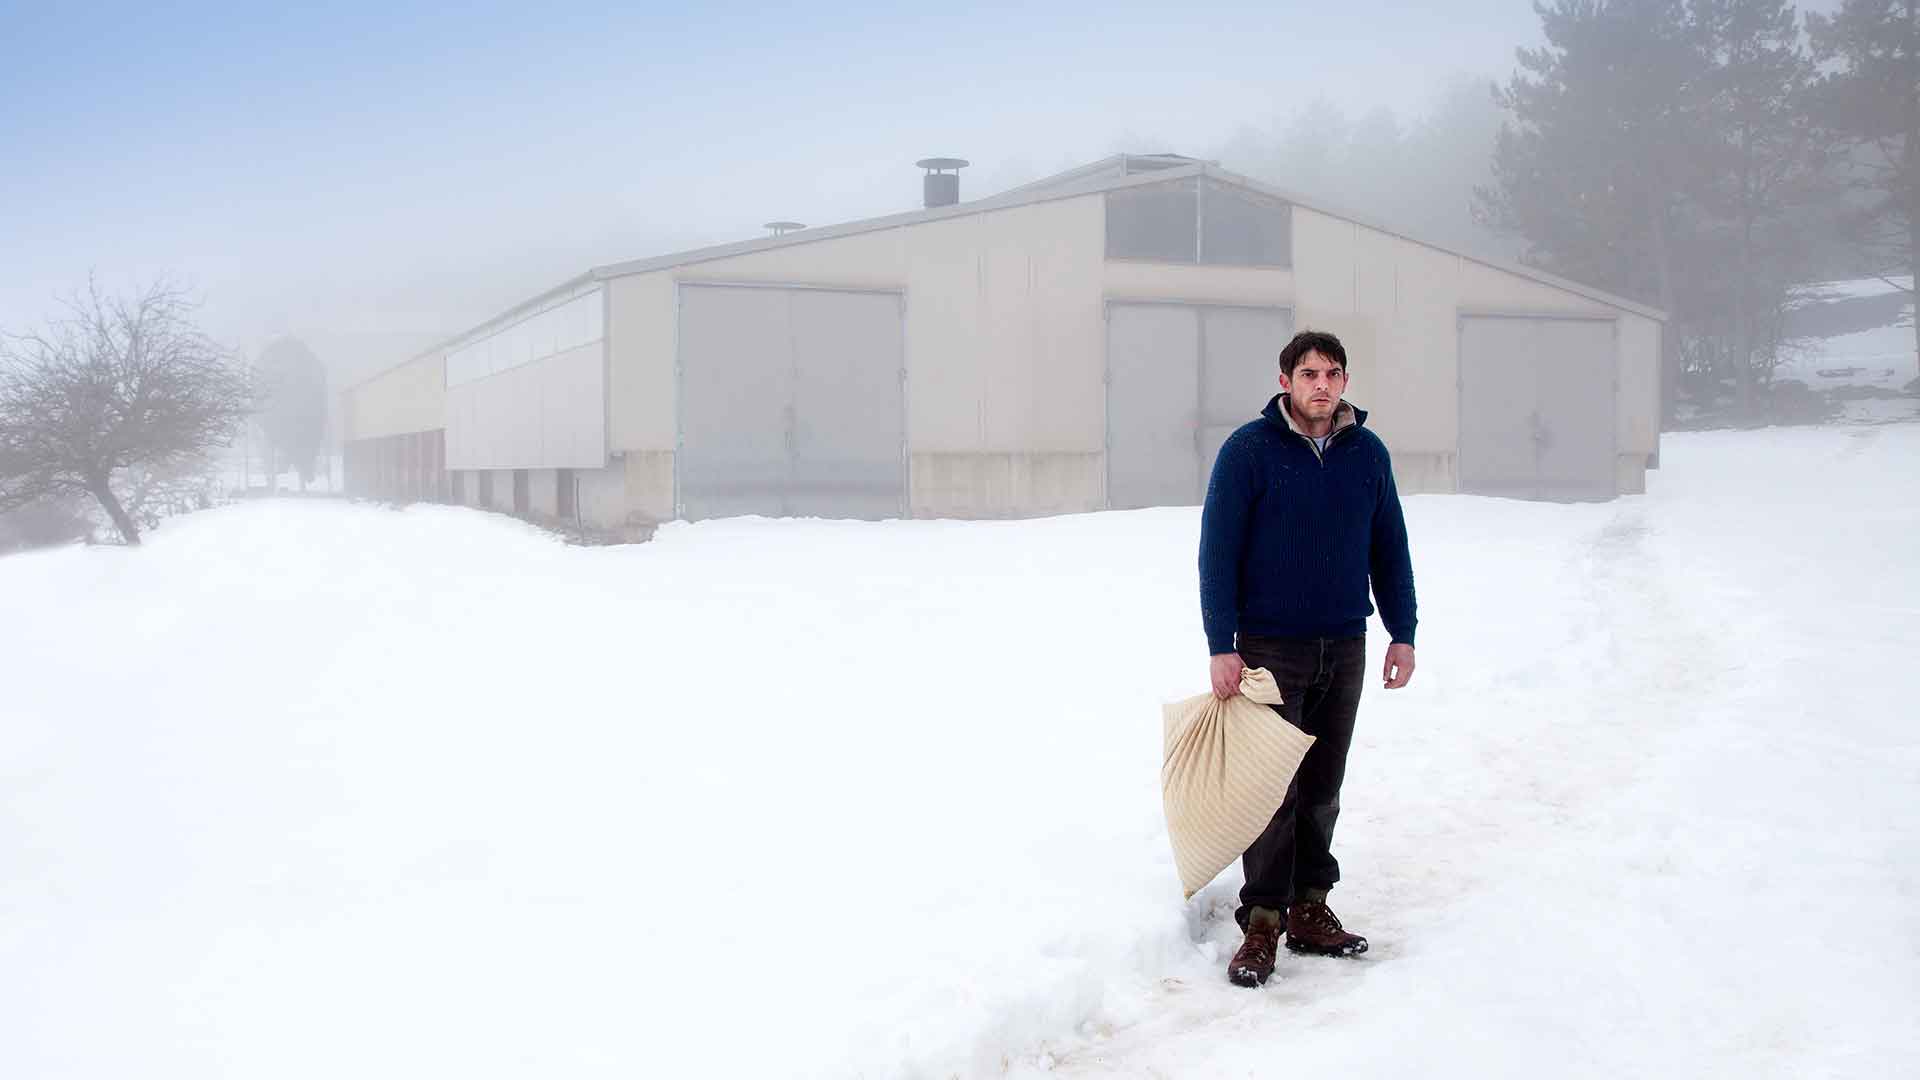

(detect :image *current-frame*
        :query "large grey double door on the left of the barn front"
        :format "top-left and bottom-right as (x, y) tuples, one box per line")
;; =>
(678, 284), (906, 519)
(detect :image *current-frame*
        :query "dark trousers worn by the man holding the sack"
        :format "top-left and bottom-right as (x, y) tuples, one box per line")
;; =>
(1235, 634), (1367, 928)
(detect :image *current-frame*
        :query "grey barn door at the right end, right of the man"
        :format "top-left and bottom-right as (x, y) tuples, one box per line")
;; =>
(1459, 315), (1617, 500)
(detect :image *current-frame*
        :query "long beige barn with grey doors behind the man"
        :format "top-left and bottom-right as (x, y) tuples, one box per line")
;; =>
(342, 156), (1663, 527)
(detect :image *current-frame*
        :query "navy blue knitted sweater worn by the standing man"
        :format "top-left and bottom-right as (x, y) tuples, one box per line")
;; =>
(1200, 396), (1415, 655)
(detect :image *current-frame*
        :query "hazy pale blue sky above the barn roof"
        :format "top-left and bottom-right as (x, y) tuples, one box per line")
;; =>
(0, 0), (1538, 368)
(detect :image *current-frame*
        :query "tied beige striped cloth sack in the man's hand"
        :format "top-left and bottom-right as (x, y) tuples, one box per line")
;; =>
(1160, 667), (1313, 899)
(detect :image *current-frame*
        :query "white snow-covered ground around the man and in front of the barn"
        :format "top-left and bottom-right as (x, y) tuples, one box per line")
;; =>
(0, 425), (1920, 1080)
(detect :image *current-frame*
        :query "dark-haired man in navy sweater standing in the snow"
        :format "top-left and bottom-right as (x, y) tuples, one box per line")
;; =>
(1200, 331), (1415, 986)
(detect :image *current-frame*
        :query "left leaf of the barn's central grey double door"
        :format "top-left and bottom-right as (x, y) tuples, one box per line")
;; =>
(1106, 304), (1200, 509)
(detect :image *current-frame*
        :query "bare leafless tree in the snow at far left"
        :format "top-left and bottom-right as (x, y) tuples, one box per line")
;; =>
(0, 282), (253, 544)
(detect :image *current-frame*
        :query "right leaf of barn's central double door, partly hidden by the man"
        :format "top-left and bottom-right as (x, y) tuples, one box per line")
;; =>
(1200, 307), (1294, 496)
